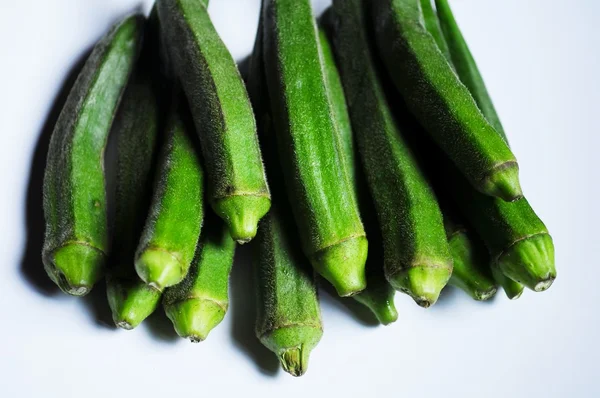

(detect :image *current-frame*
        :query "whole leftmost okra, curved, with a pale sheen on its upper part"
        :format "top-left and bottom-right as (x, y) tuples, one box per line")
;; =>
(42, 15), (144, 296)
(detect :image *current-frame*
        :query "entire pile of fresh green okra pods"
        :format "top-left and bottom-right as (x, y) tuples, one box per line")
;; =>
(42, 0), (556, 376)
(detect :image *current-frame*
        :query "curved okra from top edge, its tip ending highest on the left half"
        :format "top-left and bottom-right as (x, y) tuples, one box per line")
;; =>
(157, 0), (271, 243)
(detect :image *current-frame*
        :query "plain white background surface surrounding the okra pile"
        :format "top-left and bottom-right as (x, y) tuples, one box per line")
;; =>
(0, 0), (600, 398)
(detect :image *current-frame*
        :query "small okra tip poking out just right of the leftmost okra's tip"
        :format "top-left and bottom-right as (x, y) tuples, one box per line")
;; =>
(107, 278), (161, 330)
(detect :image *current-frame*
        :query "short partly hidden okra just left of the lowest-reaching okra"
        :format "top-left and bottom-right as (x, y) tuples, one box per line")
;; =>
(163, 211), (235, 342)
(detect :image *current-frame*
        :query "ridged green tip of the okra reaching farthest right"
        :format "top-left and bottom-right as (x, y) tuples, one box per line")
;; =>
(498, 233), (556, 292)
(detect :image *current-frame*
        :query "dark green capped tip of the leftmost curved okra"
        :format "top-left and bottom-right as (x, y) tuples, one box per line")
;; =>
(44, 243), (106, 296)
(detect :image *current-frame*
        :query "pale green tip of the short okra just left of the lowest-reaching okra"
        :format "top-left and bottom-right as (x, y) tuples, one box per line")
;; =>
(164, 297), (227, 343)
